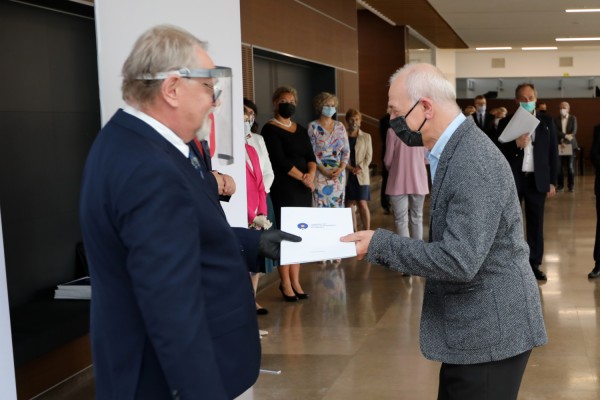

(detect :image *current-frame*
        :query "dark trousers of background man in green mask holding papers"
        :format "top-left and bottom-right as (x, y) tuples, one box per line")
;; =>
(519, 172), (547, 267)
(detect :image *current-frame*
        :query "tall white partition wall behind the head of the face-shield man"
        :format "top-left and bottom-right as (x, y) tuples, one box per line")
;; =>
(94, 0), (247, 226)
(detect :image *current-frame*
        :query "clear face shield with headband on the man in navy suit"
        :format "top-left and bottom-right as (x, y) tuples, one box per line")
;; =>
(138, 67), (233, 165)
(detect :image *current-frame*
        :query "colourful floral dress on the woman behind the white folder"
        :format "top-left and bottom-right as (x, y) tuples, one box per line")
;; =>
(308, 121), (350, 207)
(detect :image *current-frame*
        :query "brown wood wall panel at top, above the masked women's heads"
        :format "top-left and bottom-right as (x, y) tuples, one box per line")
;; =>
(240, 0), (358, 71)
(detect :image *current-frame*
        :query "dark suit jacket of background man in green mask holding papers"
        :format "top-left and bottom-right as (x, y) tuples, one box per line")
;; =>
(498, 113), (558, 194)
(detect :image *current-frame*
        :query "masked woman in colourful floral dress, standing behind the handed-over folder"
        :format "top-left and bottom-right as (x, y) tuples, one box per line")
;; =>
(308, 92), (350, 208)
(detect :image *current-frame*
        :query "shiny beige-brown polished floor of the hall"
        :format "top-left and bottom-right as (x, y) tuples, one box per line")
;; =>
(38, 176), (600, 400)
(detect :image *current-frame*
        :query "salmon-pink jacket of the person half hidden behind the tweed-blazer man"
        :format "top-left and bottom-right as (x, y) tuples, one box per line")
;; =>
(383, 128), (429, 196)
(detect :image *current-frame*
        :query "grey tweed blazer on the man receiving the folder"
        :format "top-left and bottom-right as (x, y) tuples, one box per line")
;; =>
(366, 118), (547, 364)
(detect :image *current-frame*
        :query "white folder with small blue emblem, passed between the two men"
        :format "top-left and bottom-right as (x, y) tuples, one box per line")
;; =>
(280, 207), (356, 265)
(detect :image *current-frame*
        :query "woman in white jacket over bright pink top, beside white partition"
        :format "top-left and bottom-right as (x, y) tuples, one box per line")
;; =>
(244, 98), (274, 322)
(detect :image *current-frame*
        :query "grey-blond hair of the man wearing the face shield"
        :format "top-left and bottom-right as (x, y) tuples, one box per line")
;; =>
(121, 25), (206, 104)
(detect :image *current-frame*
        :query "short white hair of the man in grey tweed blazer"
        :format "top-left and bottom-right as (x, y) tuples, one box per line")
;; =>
(390, 63), (460, 111)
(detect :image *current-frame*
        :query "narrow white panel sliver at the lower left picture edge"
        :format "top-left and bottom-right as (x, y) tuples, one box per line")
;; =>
(0, 209), (17, 400)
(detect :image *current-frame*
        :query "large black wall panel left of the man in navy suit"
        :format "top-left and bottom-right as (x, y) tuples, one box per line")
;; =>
(0, 1), (100, 307)
